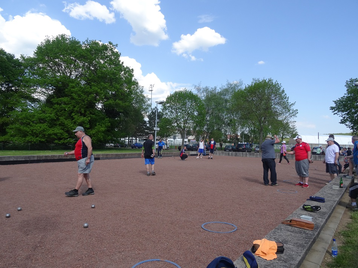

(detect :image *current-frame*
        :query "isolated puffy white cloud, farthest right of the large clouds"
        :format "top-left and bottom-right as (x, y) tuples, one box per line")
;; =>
(172, 27), (226, 60)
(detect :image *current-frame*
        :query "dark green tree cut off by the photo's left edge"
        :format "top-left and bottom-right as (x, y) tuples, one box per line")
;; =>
(0, 49), (33, 141)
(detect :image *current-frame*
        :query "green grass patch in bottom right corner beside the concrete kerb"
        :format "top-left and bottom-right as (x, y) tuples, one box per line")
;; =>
(327, 212), (358, 268)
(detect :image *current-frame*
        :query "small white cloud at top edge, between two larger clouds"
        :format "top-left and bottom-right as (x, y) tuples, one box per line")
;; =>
(62, 0), (116, 24)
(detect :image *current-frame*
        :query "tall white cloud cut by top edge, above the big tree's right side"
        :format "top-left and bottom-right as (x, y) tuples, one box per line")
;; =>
(111, 0), (168, 46)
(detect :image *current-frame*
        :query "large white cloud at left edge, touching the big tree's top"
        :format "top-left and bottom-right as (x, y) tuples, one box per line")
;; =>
(0, 10), (71, 57)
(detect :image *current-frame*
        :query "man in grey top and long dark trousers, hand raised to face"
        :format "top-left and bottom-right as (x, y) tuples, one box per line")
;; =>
(261, 135), (280, 186)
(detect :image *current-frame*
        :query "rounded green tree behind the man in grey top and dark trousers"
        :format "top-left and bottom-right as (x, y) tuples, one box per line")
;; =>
(233, 79), (297, 144)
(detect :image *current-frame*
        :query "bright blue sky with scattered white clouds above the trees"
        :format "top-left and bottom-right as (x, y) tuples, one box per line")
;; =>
(0, 0), (358, 135)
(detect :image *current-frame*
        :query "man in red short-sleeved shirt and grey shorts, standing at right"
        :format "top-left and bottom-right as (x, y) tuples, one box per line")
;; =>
(287, 135), (313, 188)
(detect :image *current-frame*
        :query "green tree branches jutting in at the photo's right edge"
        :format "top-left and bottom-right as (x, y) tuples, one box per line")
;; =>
(330, 78), (358, 134)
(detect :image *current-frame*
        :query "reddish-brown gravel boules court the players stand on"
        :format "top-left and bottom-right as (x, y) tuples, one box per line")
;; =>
(0, 156), (328, 268)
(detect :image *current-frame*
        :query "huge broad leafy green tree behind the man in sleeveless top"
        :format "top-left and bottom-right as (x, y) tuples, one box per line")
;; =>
(10, 35), (141, 144)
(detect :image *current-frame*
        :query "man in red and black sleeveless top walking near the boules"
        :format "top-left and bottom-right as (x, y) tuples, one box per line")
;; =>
(64, 126), (94, 197)
